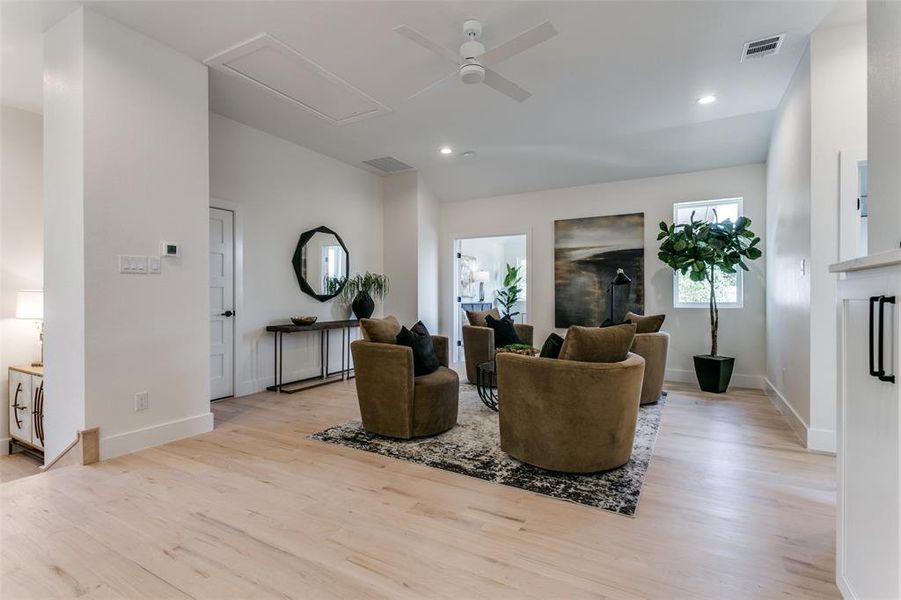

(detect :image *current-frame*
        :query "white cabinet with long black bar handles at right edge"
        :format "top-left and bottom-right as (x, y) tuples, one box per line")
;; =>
(836, 266), (901, 600)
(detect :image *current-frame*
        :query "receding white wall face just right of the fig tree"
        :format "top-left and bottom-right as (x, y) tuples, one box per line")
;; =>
(765, 44), (811, 440)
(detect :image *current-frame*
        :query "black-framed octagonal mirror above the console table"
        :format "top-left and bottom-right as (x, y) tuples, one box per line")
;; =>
(291, 227), (350, 302)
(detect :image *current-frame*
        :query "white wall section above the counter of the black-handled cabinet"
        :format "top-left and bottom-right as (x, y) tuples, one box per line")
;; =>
(867, 0), (901, 254)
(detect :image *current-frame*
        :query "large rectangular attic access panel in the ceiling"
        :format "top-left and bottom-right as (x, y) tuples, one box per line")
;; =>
(204, 33), (391, 125)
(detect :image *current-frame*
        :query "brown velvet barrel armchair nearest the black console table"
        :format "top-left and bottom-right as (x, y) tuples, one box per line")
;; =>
(350, 335), (460, 439)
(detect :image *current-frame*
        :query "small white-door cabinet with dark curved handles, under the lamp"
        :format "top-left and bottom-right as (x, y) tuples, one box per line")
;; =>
(9, 367), (44, 450)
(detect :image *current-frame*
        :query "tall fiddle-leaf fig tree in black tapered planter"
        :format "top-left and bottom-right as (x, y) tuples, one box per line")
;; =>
(657, 211), (763, 394)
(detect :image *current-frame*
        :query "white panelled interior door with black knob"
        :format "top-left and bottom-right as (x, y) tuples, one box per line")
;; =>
(210, 208), (235, 400)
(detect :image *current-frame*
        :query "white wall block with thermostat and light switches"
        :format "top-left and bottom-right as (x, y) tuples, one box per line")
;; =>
(44, 9), (213, 458)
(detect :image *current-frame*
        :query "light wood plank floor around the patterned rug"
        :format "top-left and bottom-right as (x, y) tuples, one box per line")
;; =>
(0, 383), (838, 600)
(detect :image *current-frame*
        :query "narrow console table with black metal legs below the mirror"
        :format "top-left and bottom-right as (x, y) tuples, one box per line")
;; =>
(266, 320), (360, 394)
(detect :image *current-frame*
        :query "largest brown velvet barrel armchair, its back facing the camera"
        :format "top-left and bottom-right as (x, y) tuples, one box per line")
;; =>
(496, 353), (644, 473)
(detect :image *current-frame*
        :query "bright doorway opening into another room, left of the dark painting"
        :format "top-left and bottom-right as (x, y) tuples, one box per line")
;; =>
(453, 234), (528, 362)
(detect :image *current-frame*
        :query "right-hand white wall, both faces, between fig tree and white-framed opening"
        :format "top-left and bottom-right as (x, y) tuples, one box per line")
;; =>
(767, 24), (867, 451)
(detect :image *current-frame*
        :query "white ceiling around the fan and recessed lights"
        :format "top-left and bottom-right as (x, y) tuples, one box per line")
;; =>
(2, 0), (862, 200)
